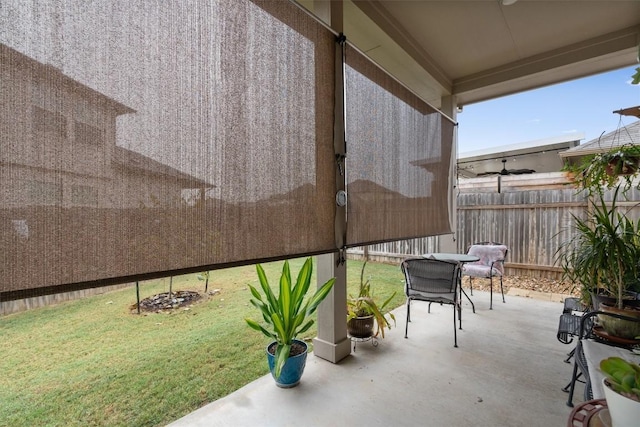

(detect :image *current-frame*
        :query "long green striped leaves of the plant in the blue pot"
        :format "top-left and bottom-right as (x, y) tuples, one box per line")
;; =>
(245, 258), (335, 378)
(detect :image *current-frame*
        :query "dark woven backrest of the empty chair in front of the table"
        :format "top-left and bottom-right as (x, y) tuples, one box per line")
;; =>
(402, 258), (460, 300)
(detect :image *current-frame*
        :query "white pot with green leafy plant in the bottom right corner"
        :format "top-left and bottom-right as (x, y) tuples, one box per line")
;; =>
(600, 357), (640, 427)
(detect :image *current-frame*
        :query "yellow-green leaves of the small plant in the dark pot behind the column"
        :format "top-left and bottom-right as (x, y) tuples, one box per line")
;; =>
(347, 261), (397, 338)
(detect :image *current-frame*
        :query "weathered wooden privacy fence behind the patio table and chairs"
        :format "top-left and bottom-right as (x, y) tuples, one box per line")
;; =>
(350, 172), (640, 279)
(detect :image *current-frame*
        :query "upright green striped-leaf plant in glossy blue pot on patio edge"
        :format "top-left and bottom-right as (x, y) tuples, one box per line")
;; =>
(245, 258), (335, 388)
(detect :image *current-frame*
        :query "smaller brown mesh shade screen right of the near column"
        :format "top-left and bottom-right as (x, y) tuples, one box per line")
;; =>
(345, 45), (454, 246)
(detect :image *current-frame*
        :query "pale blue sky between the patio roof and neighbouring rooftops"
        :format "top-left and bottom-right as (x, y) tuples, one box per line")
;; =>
(457, 65), (640, 153)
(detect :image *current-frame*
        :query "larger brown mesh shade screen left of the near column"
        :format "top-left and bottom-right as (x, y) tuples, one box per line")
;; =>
(0, 0), (335, 300)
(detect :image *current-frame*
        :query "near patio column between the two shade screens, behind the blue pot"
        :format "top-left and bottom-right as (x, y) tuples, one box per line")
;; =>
(313, 1), (351, 363)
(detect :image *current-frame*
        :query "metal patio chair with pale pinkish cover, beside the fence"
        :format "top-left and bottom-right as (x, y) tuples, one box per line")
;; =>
(462, 242), (509, 310)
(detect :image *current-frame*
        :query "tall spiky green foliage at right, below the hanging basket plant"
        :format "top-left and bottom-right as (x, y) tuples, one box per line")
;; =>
(557, 187), (640, 308)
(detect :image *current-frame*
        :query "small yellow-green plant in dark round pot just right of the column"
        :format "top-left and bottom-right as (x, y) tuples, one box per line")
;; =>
(347, 261), (396, 338)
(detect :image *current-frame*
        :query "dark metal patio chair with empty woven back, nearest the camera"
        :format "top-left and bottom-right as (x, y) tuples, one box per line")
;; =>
(401, 258), (462, 347)
